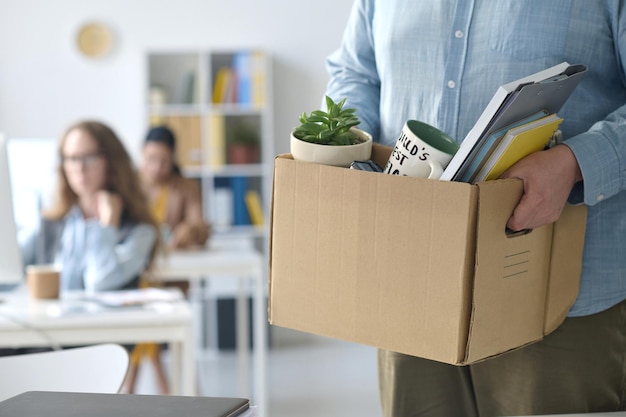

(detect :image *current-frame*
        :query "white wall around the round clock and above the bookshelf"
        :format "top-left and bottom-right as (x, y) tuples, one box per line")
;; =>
(0, 0), (352, 156)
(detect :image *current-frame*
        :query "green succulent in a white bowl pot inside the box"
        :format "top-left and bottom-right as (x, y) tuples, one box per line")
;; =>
(290, 96), (372, 167)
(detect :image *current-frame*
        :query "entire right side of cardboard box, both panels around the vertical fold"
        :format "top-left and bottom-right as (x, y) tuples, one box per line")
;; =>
(465, 180), (586, 363)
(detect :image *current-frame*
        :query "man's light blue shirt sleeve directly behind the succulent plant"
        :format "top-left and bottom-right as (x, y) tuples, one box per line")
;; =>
(322, 0), (380, 140)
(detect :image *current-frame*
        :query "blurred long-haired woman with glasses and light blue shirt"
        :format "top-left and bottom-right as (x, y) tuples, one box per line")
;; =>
(20, 121), (159, 292)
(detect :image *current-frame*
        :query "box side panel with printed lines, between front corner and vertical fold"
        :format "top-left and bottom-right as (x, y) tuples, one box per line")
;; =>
(466, 180), (552, 363)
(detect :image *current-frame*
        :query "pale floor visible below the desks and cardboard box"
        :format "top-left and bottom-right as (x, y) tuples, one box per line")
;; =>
(130, 329), (381, 417)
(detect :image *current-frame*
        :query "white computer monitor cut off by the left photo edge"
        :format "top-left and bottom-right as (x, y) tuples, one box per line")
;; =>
(0, 133), (24, 289)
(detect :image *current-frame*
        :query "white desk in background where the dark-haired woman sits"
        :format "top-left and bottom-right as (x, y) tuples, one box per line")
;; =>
(155, 240), (267, 417)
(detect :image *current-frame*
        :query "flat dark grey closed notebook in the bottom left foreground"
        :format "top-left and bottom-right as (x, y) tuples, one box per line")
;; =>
(0, 391), (250, 417)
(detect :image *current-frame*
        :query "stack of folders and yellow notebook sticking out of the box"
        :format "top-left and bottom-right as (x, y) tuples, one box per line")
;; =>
(440, 62), (587, 183)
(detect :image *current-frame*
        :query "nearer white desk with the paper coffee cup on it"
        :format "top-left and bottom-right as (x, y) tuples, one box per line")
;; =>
(0, 288), (196, 395)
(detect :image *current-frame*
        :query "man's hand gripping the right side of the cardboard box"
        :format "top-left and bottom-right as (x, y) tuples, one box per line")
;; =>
(500, 145), (582, 230)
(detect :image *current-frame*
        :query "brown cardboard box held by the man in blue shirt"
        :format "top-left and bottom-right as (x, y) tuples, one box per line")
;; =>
(269, 145), (586, 365)
